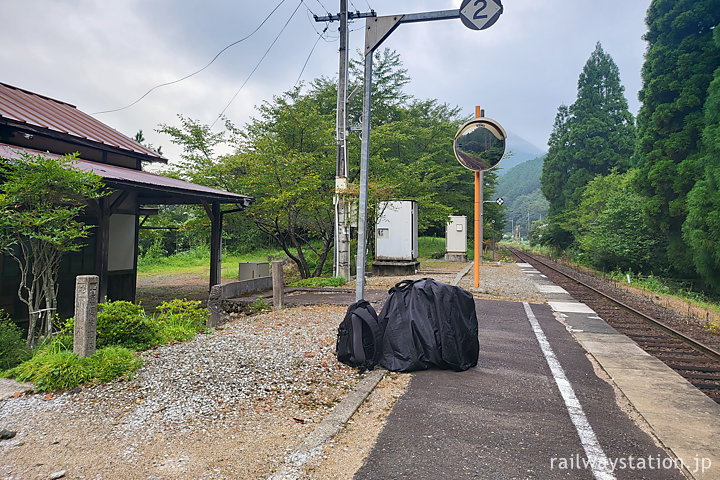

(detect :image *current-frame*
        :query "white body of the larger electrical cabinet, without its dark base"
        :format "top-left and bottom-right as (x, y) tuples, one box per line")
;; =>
(375, 200), (418, 260)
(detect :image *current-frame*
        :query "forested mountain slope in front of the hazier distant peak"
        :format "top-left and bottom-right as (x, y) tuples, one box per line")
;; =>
(496, 155), (548, 238)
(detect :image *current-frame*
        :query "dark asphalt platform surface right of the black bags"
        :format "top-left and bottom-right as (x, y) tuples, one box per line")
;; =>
(355, 299), (685, 480)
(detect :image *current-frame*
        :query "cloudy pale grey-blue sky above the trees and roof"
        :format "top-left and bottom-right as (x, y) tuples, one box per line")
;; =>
(0, 0), (650, 160)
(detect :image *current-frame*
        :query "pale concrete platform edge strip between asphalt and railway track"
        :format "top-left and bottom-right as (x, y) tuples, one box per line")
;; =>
(534, 266), (720, 480)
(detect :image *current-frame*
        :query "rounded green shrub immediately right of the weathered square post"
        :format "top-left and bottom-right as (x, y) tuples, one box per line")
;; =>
(97, 300), (156, 350)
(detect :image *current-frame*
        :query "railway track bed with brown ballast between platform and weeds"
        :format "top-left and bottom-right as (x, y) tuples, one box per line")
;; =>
(511, 248), (720, 403)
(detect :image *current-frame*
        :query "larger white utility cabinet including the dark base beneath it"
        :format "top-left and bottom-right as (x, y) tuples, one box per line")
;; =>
(372, 200), (420, 275)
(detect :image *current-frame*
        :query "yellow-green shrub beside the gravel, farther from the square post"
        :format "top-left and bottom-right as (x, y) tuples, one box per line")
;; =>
(154, 298), (209, 344)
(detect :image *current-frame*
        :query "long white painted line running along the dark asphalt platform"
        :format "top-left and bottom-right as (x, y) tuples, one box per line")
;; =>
(523, 302), (615, 480)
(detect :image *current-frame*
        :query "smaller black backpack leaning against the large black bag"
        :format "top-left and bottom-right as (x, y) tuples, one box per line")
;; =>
(336, 300), (383, 373)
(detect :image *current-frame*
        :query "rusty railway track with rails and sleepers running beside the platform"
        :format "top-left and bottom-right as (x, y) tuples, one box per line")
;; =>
(511, 249), (720, 403)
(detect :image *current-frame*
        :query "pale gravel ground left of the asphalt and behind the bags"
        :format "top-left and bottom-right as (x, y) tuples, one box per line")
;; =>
(0, 264), (542, 480)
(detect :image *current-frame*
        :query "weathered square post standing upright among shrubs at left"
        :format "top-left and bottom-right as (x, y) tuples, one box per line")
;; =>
(73, 275), (100, 357)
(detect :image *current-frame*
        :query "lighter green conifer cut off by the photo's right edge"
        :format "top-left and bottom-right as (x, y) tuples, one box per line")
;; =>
(683, 28), (720, 293)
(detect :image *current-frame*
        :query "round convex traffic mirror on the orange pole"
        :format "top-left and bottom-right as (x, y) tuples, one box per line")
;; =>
(453, 117), (507, 171)
